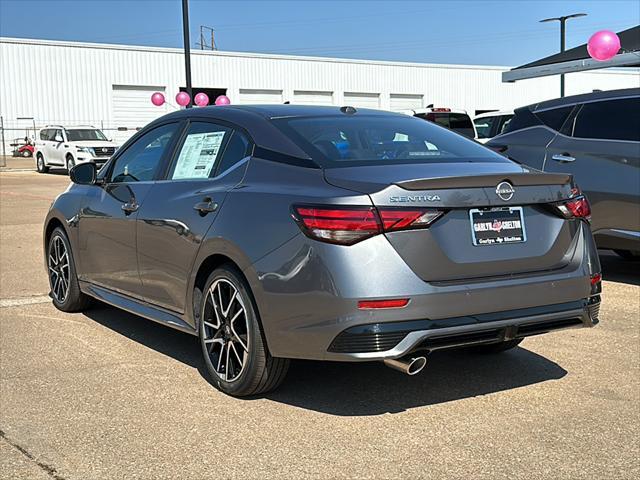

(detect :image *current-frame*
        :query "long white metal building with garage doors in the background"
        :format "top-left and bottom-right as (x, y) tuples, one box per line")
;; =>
(0, 37), (640, 146)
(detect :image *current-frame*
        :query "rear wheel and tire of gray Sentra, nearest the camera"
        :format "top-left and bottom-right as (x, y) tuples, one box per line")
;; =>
(198, 265), (289, 397)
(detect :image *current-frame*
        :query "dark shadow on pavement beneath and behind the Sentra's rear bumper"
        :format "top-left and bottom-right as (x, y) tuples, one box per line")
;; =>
(267, 348), (567, 416)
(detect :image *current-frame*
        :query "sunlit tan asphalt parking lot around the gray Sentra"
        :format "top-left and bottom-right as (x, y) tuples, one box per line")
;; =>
(0, 165), (640, 480)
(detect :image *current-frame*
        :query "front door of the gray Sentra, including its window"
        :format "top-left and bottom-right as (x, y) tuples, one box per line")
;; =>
(78, 122), (181, 297)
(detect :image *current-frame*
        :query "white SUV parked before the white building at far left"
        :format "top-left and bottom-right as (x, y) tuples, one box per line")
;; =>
(34, 125), (118, 173)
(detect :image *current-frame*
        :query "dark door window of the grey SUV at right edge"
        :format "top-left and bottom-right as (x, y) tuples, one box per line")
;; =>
(573, 98), (640, 142)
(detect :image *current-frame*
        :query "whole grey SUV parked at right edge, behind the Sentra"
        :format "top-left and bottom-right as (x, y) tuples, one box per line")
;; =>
(487, 88), (640, 259)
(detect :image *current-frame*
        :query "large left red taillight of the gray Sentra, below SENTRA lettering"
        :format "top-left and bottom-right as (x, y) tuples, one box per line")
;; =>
(293, 205), (444, 245)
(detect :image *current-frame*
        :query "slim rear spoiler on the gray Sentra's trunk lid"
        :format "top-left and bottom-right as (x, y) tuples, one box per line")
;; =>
(395, 172), (573, 190)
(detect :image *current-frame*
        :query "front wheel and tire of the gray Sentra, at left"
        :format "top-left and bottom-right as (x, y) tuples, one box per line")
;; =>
(47, 227), (91, 312)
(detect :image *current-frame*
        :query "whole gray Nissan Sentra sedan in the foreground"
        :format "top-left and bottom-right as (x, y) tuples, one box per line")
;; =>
(44, 105), (601, 396)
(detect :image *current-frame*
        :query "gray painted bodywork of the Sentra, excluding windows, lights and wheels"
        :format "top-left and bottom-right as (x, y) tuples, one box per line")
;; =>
(44, 106), (600, 361)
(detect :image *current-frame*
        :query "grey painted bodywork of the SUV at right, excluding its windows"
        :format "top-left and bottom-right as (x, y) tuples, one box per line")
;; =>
(487, 88), (640, 251)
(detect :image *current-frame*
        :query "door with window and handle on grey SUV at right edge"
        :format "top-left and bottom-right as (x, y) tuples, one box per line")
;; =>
(544, 98), (640, 237)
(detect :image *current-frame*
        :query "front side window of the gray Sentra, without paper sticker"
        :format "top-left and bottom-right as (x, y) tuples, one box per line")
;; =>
(111, 123), (178, 183)
